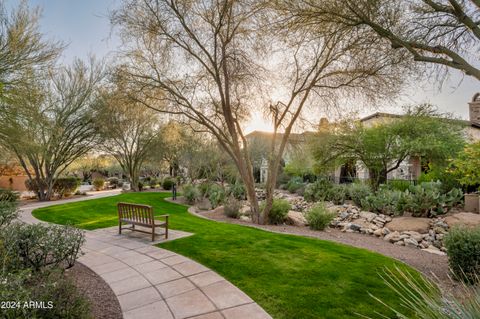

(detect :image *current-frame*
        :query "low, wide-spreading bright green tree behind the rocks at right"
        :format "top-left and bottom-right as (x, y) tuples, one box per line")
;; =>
(311, 105), (465, 189)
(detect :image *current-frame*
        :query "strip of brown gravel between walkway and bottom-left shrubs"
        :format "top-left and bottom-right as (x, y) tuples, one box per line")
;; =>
(66, 262), (123, 319)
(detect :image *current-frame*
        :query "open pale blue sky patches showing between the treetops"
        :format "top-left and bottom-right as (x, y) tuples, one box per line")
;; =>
(4, 0), (480, 132)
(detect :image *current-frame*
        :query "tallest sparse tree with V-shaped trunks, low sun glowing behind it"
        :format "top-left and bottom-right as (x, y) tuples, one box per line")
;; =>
(112, 0), (408, 223)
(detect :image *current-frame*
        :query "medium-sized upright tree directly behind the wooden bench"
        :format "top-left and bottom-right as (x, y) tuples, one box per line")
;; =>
(95, 86), (161, 191)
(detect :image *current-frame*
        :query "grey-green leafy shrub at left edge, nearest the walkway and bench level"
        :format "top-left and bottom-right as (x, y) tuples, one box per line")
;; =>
(1, 223), (85, 271)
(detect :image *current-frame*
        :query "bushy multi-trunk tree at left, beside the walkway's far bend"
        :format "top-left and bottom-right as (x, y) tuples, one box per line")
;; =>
(0, 60), (103, 200)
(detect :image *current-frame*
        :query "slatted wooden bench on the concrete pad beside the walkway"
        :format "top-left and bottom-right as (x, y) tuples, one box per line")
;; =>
(117, 203), (168, 241)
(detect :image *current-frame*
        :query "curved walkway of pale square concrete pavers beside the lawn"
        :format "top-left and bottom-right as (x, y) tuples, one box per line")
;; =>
(20, 192), (271, 319)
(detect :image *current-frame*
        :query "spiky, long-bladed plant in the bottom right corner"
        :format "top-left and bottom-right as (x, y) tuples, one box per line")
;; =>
(358, 267), (480, 319)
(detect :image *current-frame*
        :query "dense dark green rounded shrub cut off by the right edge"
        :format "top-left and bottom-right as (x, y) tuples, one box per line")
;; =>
(443, 227), (480, 283)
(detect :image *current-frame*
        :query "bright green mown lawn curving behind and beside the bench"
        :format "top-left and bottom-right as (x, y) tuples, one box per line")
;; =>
(33, 193), (416, 319)
